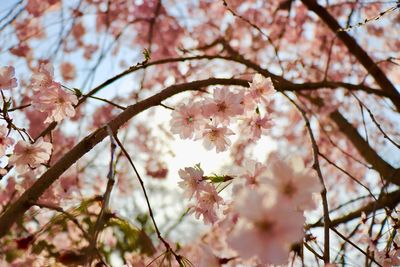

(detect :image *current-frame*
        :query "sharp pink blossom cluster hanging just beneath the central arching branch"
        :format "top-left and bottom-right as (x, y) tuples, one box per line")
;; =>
(170, 74), (274, 152)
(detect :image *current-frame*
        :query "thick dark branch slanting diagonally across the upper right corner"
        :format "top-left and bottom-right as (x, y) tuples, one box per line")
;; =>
(302, 0), (400, 111)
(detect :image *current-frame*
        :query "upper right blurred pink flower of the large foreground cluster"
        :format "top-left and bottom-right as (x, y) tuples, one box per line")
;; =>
(264, 153), (322, 213)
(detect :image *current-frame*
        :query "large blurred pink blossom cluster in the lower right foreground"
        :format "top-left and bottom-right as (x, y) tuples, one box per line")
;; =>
(227, 153), (321, 264)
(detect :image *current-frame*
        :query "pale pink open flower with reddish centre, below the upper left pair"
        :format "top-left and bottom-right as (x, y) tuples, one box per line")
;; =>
(9, 137), (53, 174)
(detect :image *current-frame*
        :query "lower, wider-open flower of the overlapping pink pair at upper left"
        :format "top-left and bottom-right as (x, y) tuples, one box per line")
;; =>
(32, 86), (78, 123)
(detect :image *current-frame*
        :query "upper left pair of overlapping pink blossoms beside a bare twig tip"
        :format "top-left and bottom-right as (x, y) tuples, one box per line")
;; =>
(30, 63), (78, 123)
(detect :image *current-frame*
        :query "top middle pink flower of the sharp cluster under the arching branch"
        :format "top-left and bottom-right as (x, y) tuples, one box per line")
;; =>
(201, 88), (243, 125)
